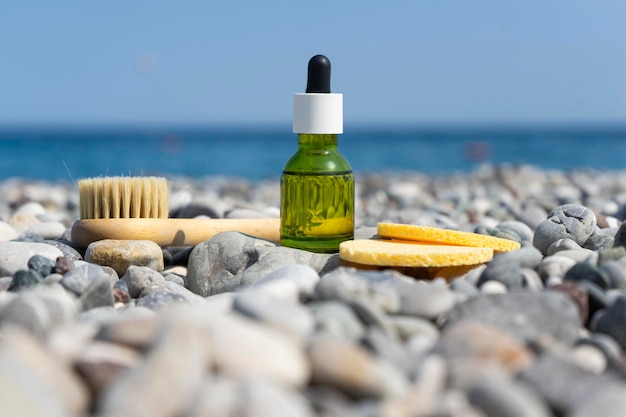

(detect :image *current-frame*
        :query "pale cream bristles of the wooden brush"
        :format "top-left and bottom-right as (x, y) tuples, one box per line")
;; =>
(78, 177), (169, 219)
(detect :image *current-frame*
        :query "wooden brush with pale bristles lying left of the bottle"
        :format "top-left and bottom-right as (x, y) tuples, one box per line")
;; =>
(72, 177), (280, 247)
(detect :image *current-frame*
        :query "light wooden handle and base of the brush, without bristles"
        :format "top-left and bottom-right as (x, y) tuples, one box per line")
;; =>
(72, 218), (280, 248)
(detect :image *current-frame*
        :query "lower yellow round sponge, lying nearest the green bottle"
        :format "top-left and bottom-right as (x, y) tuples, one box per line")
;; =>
(339, 239), (493, 267)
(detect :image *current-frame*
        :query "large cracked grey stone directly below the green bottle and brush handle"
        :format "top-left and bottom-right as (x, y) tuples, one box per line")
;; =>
(187, 232), (340, 297)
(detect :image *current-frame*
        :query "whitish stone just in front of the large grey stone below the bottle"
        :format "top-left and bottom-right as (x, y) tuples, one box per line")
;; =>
(250, 264), (320, 298)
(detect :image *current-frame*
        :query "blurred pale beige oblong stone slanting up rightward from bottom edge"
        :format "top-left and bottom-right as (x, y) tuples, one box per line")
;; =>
(96, 320), (211, 417)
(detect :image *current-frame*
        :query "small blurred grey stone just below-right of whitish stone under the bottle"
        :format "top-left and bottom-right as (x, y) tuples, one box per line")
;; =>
(309, 300), (365, 341)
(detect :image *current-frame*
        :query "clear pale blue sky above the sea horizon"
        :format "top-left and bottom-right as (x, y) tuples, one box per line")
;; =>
(0, 0), (626, 125)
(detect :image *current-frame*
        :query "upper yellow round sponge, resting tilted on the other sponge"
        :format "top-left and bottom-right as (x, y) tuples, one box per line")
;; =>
(378, 223), (521, 252)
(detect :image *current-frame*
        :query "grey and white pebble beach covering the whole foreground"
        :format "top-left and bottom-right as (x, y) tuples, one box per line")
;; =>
(0, 165), (626, 417)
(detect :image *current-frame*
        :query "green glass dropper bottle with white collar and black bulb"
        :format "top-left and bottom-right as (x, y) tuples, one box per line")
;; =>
(280, 55), (354, 253)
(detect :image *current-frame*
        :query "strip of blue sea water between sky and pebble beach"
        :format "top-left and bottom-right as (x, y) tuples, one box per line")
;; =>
(0, 126), (626, 180)
